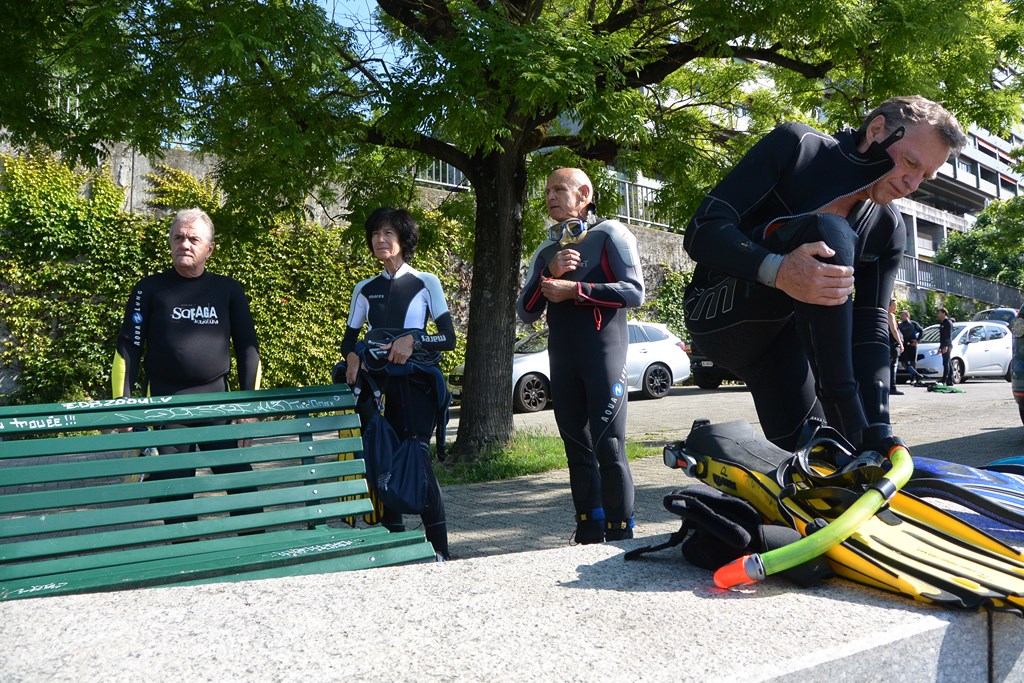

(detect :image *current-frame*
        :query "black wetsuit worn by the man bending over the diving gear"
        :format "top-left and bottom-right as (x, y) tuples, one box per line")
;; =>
(684, 123), (906, 450)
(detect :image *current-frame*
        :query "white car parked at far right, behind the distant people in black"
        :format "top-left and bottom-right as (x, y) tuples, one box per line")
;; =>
(918, 321), (1013, 384)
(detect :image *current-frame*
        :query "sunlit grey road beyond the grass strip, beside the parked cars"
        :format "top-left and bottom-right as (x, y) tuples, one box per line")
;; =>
(449, 379), (1024, 465)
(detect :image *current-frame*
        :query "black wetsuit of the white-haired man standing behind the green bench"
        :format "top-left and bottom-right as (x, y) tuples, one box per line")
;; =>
(111, 268), (260, 521)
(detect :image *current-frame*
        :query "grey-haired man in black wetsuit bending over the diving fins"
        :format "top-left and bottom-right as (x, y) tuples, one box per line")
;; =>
(684, 96), (967, 450)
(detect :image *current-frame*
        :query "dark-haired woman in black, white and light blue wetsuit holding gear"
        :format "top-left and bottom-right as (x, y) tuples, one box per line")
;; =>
(341, 207), (456, 560)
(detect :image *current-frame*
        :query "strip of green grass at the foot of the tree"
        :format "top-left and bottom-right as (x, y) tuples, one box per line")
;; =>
(434, 432), (662, 486)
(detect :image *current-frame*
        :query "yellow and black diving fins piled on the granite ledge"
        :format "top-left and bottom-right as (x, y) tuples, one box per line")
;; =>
(682, 421), (1024, 615)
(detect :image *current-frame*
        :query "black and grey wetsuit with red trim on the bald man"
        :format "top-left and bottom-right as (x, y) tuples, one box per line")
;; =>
(517, 220), (644, 542)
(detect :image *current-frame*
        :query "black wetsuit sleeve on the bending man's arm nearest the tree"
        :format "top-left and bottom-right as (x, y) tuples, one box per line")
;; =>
(683, 124), (800, 282)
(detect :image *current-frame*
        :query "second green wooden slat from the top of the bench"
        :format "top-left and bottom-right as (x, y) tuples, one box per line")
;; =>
(0, 414), (359, 459)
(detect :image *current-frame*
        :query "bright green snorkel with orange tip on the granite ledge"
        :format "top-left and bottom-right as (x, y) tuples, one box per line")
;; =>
(708, 444), (913, 588)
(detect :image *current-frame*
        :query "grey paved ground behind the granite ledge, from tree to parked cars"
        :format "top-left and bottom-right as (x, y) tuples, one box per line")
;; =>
(442, 380), (1024, 558)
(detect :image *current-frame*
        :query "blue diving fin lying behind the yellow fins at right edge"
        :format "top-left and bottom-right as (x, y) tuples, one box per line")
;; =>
(903, 458), (1024, 540)
